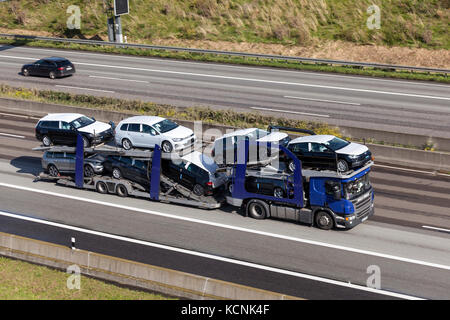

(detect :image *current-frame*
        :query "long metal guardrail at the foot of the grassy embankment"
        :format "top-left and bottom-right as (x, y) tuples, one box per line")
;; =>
(0, 33), (450, 76)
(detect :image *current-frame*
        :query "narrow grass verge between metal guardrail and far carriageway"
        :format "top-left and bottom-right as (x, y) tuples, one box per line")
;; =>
(0, 38), (450, 83)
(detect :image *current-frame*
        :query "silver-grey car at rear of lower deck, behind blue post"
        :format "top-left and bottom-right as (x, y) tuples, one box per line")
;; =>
(41, 151), (105, 177)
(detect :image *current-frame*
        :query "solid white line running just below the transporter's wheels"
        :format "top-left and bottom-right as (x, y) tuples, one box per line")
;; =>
(0, 182), (450, 271)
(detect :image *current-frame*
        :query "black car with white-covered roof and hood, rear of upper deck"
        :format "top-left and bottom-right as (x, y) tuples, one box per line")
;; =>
(35, 113), (114, 148)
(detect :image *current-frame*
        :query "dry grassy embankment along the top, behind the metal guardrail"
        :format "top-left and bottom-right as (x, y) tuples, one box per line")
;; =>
(0, 0), (450, 49)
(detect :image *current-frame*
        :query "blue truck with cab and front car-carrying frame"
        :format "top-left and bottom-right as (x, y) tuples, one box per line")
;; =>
(226, 141), (374, 230)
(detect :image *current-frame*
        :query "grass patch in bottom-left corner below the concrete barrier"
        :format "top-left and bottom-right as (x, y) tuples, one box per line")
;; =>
(0, 256), (173, 300)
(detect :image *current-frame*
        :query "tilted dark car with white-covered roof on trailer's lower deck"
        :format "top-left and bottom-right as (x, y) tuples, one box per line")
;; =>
(161, 151), (228, 196)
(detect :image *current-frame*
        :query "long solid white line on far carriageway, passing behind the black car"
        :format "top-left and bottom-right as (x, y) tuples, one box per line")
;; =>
(0, 55), (450, 101)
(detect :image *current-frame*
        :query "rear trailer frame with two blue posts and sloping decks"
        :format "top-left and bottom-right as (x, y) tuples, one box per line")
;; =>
(33, 137), (225, 209)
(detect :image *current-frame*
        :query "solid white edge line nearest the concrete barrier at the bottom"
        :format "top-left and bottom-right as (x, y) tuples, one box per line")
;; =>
(0, 211), (423, 300)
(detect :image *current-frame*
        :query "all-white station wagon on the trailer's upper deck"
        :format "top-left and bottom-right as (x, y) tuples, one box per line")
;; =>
(115, 116), (196, 152)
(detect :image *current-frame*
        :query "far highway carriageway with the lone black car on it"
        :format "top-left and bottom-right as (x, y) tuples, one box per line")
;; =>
(0, 45), (450, 138)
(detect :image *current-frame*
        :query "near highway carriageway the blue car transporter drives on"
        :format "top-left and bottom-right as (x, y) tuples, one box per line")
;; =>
(0, 113), (450, 299)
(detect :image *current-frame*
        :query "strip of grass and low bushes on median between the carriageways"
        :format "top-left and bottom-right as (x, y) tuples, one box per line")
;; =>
(0, 84), (341, 136)
